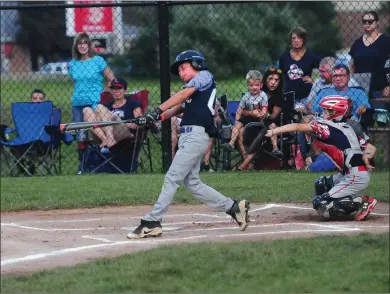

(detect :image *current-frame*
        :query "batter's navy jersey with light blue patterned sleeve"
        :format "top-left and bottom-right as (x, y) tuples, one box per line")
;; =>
(180, 70), (216, 134)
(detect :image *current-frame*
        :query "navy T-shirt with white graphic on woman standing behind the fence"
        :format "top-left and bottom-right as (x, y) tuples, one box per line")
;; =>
(279, 50), (321, 100)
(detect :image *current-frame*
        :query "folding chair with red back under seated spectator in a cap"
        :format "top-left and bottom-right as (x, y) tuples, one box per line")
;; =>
(79, 90), (153, 173)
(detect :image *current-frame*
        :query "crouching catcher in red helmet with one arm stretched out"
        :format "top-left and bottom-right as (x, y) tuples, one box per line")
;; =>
(266, 96), (377, 221)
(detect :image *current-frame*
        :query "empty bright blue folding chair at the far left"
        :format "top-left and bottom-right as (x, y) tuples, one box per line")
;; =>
(0, 101), (57, 176)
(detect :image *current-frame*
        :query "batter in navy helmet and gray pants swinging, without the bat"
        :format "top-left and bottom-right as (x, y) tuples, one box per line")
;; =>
(127, 50), (249, 239)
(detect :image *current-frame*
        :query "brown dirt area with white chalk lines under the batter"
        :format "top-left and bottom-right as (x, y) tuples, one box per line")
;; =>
(1, 203), (389, 274)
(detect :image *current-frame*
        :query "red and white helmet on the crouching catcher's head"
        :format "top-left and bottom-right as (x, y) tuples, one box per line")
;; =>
(320, 95), (352, 122)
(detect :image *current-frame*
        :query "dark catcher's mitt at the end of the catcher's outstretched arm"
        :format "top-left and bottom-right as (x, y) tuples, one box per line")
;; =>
(243, 122), (267, 154)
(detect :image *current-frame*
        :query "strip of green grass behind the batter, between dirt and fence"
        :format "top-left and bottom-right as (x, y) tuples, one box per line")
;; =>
(1, 171), (389, 211)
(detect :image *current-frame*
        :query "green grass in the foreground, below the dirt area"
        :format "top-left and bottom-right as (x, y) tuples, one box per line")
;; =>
(2, 234), (389, 293)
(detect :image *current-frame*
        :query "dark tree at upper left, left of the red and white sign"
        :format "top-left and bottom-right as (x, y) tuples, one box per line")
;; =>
(16, 1), (72, 71)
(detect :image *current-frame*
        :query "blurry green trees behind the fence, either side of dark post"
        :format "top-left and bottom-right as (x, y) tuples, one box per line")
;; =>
(123, 2), (341, 78)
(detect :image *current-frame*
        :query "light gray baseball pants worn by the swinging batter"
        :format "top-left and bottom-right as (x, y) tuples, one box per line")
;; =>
(143, 126), (234, 221)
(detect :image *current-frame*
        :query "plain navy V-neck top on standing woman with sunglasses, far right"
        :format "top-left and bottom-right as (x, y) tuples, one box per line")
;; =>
(349, 34), (390, 91)
